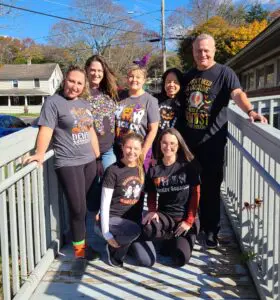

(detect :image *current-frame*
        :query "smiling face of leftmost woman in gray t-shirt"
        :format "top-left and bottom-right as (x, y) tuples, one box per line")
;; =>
(63, 71), (85, 100)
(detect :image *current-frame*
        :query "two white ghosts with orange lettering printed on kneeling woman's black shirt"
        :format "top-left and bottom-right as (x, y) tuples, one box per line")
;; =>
(120, 176), (143, 205)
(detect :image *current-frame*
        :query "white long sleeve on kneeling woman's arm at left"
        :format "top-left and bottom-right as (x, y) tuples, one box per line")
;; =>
(100, 187), (114, 240)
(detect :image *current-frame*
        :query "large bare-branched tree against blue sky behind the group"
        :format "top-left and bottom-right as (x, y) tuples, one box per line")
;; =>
(47, 0), (153, 54)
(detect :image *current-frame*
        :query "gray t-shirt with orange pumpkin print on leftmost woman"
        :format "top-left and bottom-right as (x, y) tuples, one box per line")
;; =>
(38, 94), (95, 168)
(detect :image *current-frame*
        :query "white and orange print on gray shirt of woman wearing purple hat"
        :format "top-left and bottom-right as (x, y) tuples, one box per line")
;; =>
(116, 103), (145, 138)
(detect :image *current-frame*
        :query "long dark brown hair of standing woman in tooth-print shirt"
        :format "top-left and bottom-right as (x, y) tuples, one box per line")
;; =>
(85, 54), (118, 99)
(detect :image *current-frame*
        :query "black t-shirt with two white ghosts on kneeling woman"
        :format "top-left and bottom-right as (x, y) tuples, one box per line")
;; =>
(102, 162), (143, 221)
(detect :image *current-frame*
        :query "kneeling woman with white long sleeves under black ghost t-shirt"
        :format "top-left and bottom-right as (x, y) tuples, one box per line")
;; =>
(101, 133), (155, 266)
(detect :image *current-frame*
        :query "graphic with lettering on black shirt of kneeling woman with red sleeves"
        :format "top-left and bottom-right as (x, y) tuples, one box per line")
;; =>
(153, 173), (189, 193)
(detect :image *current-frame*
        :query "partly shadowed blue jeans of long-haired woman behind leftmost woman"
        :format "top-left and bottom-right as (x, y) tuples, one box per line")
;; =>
(87, 147), (116, 212)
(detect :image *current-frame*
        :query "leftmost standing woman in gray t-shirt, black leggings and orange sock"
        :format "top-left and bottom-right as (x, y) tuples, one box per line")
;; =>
(26, 66), (100, 259)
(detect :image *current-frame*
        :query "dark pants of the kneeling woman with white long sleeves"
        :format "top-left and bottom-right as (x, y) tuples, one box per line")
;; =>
(109, 217), (156, 266)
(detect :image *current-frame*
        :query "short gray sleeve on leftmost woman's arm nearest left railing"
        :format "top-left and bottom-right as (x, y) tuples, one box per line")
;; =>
(38, 97), (58, 129)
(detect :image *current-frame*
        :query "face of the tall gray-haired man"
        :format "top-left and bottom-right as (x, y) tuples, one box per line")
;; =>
(193, 39), (216, 70)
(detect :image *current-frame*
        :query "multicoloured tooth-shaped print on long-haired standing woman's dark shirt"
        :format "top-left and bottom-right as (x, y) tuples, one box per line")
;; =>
(90, 94), (116, 135)
